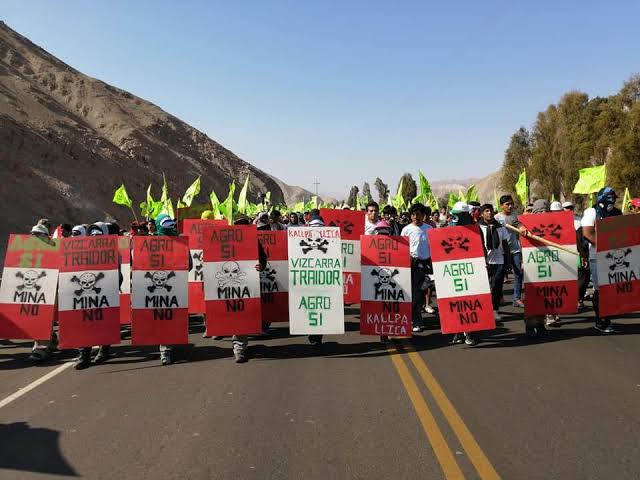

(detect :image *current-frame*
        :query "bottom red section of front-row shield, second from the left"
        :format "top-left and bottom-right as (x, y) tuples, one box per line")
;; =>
(58, 307), (120, 349)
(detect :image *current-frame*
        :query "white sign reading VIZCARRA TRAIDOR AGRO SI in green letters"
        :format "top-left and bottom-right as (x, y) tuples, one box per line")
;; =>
(287, 227), (344, 335)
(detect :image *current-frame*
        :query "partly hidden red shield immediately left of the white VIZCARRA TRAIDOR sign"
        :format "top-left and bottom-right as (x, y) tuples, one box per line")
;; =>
(258, 231), (289, 325)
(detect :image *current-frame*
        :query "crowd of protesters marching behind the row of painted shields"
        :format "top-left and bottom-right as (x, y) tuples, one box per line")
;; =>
(10, 187), (640, 369)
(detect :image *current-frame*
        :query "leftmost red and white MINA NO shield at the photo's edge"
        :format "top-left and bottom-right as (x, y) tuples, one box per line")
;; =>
(0, 235), (60, 340)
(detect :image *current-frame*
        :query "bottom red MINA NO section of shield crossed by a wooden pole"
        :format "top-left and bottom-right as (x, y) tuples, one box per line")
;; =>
(524, 281), (578, 317)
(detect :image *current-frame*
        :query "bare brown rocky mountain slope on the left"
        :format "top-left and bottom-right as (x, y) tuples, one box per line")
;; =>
(0, 22), (284, 250)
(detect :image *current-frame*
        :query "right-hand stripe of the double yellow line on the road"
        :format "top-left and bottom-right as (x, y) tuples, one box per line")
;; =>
(396, 340), (500, 480)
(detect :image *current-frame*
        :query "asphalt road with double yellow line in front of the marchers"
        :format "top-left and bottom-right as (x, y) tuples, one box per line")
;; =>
(0, 290), (640, 480)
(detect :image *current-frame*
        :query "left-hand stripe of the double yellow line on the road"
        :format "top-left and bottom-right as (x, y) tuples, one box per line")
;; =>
(387, 346), (464, 480)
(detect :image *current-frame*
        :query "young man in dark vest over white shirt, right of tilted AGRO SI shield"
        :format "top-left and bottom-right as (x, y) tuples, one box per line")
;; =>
(478, 202), (510, 322)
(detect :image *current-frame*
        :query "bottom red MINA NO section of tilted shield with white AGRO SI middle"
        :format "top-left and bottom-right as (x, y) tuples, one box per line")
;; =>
(430, 292), (496, 333)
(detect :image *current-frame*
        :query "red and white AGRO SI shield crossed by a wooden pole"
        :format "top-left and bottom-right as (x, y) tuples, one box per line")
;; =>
(518, 212), (578, 317)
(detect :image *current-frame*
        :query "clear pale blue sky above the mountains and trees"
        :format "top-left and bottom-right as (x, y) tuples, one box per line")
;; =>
(0, 0), (640, 197)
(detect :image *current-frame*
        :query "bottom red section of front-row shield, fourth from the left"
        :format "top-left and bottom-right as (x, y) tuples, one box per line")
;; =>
(206, 298), (262, 336)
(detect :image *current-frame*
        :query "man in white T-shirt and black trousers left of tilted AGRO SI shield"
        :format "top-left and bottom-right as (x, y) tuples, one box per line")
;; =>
(400, 203), (433, 332)
